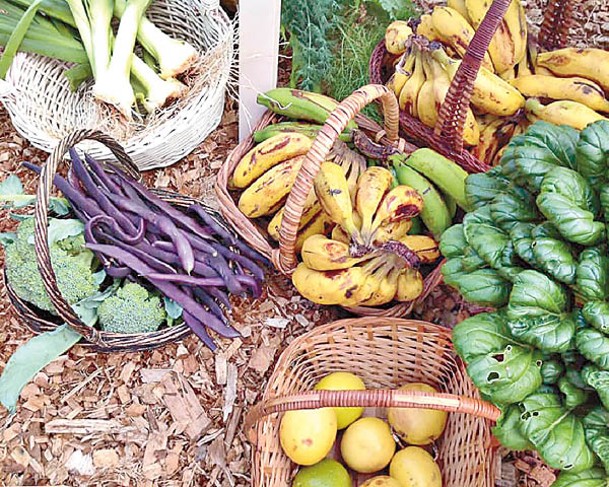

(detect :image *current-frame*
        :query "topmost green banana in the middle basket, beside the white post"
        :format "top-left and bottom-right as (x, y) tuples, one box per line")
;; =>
(256, 88), (357, 130)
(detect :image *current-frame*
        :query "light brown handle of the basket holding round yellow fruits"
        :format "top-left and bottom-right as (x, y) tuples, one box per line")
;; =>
(244, 389), (501, 443)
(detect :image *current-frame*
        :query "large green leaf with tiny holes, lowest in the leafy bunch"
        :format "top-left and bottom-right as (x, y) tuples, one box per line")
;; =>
(521, 393), (595, 472)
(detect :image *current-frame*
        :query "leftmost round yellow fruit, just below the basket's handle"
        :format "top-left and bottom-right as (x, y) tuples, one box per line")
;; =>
(279, 408), (336, 465)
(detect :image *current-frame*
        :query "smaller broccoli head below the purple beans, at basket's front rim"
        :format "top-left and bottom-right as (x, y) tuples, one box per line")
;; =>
(97, 282), (167, 333)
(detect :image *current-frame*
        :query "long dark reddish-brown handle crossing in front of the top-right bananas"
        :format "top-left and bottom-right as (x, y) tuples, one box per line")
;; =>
(435, 0), (511, 153)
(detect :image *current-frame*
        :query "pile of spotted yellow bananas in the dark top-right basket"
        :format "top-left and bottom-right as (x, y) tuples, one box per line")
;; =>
(385, 0), (609, 165)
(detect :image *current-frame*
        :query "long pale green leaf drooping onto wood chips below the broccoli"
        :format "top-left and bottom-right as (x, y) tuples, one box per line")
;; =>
(0, 325), (82, 413)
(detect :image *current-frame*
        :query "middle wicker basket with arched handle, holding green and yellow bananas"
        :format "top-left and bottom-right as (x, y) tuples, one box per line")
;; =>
(216, 85), (442, 316)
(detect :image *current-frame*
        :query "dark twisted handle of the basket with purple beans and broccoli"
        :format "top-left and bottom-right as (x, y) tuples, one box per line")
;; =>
(34, 129), (139, 343)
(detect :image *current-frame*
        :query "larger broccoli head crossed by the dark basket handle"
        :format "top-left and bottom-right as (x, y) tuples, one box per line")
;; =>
(5, 218), (98, 314)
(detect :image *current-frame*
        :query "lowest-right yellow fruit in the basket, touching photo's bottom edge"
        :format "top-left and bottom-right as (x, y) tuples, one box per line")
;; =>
(389, 446), (442, 487)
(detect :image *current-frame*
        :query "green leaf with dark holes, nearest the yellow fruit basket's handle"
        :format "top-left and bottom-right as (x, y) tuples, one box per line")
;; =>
(467, 345), (542, 405)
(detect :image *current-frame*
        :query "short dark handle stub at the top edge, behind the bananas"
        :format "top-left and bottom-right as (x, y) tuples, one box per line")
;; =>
(537, 0), (576, 51)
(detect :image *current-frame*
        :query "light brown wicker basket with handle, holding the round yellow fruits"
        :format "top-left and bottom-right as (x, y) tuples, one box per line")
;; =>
(245, 318), (499, 487)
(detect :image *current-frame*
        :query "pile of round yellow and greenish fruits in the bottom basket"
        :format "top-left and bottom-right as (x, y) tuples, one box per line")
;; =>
(279, 372), (447, 487)
